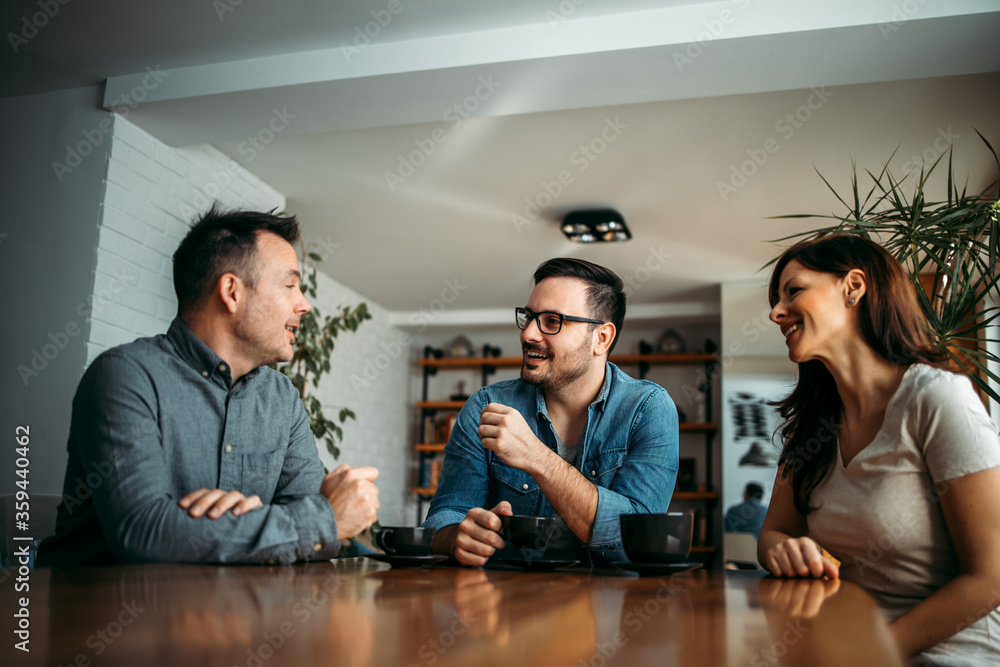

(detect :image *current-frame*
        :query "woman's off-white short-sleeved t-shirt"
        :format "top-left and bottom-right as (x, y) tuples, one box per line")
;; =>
(807, 364), (1000, 665)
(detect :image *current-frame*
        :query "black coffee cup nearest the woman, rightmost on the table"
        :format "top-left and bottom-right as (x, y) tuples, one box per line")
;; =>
(619, 512), (693, 563)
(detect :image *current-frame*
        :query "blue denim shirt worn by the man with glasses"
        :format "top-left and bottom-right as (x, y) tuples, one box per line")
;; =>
(423, 363), (678, 562)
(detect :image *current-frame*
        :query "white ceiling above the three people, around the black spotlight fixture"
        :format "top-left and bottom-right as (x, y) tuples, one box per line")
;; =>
(7, 0), (1000, 321)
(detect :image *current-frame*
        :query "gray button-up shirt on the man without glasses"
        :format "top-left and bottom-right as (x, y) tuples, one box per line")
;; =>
(38, 318), (340, 566)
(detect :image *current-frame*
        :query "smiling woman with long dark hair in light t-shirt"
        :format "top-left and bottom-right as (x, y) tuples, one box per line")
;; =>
(758, 235), (1000, 664)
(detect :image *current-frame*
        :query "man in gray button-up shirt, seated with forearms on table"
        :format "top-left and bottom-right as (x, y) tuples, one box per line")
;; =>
(38, 208), (379, 566)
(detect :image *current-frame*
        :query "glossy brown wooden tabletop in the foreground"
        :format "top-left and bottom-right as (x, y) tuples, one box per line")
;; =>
(0, 558), (902, 667)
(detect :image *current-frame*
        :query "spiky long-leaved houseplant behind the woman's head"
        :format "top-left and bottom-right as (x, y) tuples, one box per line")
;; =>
(774, 130), (1000, 401)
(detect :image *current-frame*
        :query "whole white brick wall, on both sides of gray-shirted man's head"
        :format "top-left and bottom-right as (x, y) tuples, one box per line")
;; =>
(87, 116), (416, 525)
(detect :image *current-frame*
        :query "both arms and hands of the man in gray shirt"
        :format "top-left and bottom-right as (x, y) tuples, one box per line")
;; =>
(71, 357), (378, 563)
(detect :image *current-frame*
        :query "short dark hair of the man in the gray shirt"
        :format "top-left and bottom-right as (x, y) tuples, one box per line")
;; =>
(174, 204), (299, 315)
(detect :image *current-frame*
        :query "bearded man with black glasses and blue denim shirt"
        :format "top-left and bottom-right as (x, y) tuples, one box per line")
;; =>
(424, 258), (678, 566)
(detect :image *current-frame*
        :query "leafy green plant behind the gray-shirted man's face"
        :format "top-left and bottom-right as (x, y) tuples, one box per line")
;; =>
(277, 246), (372, 460)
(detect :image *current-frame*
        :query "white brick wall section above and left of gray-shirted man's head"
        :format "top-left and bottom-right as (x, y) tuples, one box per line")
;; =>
(87, 116), (285, 364)
